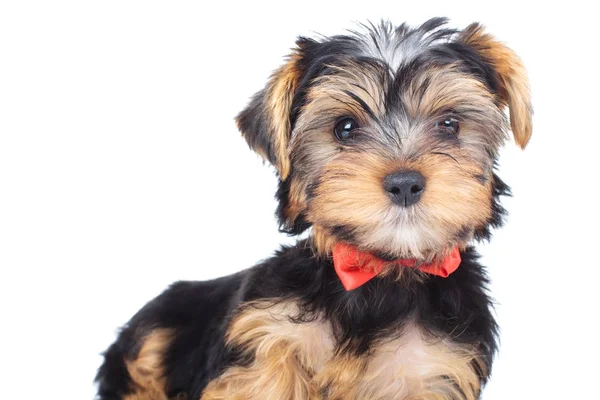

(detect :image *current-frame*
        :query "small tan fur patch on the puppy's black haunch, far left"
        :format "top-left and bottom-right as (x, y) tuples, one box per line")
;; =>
(123, 329), (172, 400)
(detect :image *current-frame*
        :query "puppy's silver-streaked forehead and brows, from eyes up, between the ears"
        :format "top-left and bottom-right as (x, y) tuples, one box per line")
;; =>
(290, 19), (503, 150)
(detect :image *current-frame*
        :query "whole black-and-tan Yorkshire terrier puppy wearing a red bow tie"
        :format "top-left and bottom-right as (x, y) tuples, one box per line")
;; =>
(96, 18), (532, 400)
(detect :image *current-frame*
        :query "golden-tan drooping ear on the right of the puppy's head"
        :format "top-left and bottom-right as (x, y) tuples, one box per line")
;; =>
(458, 23), (533, 149)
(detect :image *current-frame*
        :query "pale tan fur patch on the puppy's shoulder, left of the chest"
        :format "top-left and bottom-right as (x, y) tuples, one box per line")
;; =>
(202, 302), (333, 400)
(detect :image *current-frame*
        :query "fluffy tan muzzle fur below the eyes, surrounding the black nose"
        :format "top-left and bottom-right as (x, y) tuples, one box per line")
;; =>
(307, 144), (492, 259)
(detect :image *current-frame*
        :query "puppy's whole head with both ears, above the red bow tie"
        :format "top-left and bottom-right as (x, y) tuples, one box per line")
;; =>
(237, 19), (531, 260)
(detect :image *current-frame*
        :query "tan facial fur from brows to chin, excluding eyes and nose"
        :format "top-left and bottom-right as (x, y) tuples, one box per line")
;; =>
(285, 59), (506, 260)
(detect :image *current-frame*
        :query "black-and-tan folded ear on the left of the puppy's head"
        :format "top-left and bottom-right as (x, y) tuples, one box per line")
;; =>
(236, 38), (314, 180)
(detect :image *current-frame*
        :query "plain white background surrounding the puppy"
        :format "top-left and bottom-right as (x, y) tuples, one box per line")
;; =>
(0, 0), (600, 400)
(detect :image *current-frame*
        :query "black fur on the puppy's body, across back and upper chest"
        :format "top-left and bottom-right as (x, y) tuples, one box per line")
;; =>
(96, 241), (497, 400)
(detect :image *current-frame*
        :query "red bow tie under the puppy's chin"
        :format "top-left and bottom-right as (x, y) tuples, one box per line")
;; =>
(333, 243), (461, 290)
